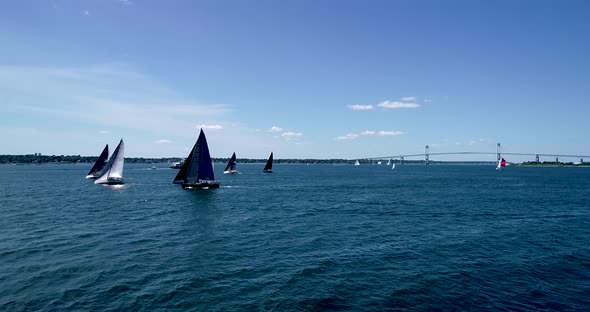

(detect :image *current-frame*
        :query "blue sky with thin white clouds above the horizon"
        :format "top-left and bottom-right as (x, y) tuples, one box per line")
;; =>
(0, 0), (590, 160)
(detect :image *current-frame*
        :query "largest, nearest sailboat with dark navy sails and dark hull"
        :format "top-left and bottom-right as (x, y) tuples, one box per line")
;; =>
(172, 129), (219, 189)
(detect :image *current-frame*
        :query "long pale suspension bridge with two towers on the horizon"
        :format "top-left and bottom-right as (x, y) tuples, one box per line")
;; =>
(359, 143), (590, 165)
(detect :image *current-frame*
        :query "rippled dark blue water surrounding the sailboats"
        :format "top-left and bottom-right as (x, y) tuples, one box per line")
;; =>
(0, 164), (590, 311)
